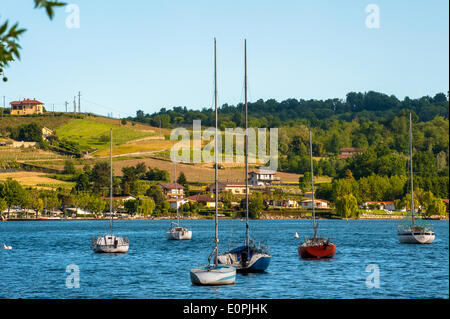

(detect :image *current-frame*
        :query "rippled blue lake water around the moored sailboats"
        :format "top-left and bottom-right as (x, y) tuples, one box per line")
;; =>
(0, 220), (449, 299)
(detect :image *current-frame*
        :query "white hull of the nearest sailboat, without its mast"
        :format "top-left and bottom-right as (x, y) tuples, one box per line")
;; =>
(190, 265), (236, 286)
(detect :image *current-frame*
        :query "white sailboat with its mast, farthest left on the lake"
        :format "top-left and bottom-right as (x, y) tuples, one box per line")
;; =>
(91, 129), (130, 253)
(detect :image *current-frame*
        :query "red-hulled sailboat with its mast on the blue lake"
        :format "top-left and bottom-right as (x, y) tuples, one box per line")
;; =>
(298, 129), (336, 259)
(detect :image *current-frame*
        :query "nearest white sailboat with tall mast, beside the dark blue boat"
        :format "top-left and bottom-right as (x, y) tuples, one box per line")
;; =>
(190, 39), (236, 286)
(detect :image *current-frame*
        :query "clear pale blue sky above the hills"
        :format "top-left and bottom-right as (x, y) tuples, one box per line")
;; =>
(0, 0), (449, 117)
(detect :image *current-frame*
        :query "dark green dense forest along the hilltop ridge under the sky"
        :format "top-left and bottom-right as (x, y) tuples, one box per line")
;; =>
(129, 91), (448, 131)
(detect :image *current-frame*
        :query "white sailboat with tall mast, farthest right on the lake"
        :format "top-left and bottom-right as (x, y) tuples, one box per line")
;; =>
(397, 113), (435, 244)
